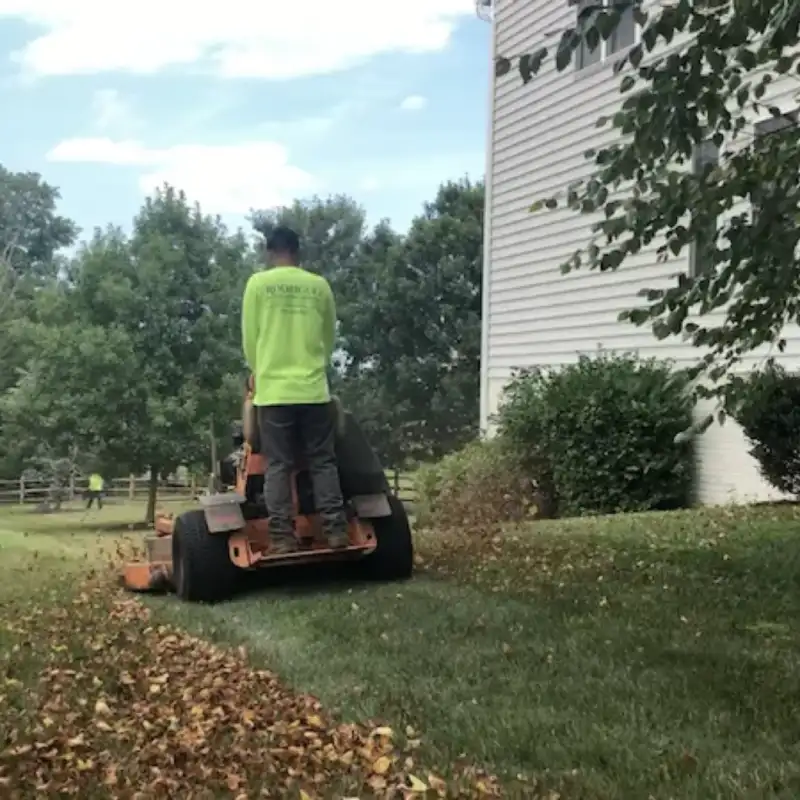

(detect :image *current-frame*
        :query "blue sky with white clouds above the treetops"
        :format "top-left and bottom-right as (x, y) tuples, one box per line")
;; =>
(0, 0), (490, 241)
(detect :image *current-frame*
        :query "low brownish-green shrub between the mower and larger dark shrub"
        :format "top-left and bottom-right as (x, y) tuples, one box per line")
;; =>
(414, 440), (546, 531)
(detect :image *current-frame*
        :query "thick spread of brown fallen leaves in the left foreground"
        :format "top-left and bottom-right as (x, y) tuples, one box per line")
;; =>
(0, 580), (499, 800)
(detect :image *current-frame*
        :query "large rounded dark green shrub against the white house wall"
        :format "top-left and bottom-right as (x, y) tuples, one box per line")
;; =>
(497, 355), (694, 516)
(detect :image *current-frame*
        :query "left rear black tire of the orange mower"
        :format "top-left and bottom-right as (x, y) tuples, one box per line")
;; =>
(172, 510), (240, 603)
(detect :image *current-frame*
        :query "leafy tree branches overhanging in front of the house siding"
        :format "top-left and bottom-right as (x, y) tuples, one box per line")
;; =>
(496, 0), (800, 428)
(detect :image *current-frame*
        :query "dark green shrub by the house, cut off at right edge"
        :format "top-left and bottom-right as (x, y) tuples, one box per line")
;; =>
(726, 364), (800, 495)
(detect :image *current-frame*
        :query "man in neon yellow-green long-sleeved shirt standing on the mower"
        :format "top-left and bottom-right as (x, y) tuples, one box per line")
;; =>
(242, 227), (348, 553)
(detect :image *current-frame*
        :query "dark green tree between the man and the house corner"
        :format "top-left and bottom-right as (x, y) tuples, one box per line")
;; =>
(341, 180), (484, 466)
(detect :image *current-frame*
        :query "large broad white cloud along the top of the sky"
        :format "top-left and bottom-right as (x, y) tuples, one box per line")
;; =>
(0, 0), (474, 79)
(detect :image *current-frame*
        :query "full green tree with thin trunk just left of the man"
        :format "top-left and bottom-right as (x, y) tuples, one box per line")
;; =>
(9, 186), (253, 521)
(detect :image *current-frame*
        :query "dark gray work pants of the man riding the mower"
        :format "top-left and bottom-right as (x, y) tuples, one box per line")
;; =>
(258, 403), (347, 536)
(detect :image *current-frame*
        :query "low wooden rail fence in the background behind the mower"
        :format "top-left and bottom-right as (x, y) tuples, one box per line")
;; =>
(0, 470), (414, 505)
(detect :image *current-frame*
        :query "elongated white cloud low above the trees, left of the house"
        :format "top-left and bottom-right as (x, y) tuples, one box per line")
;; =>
(47, 138), (318, 214)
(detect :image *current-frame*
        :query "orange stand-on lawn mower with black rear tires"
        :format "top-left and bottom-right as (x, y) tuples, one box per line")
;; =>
(123, 380), (414, 603)
